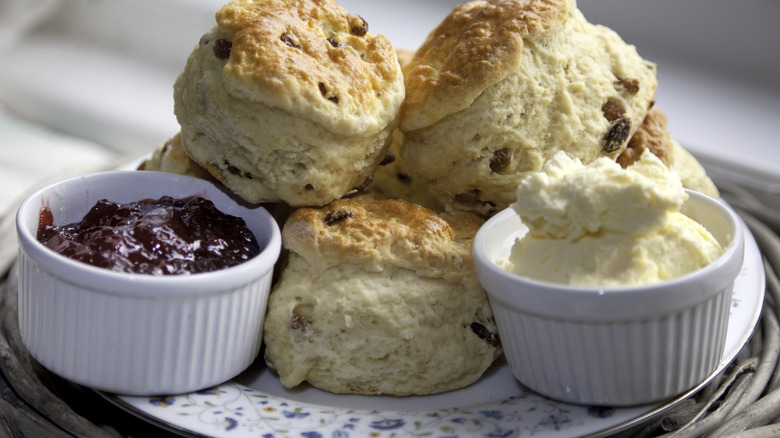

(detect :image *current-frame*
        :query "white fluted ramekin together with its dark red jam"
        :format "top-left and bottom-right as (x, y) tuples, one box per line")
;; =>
(16, 171), (281, 395)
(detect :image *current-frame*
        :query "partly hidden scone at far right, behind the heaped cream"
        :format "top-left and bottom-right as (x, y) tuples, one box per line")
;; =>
(617, 107), (720, 198)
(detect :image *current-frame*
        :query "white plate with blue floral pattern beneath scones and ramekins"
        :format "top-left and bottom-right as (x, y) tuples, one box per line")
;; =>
(103, 219), (765, 438)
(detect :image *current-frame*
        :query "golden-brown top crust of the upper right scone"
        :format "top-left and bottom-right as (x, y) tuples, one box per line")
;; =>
(401, 0), (570, 131)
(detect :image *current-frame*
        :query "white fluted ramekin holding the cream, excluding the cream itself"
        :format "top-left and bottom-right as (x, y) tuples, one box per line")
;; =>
(473, 191), (744, 406)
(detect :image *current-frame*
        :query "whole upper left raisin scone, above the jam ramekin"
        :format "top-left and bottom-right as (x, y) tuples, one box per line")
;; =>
(174, 0), (404, 206)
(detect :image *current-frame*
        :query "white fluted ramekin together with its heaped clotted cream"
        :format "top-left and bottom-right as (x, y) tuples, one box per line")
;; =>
(473, 153), (744, 406)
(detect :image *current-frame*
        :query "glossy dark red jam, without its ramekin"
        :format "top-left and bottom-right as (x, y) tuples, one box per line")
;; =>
(37, 196), (260, 275)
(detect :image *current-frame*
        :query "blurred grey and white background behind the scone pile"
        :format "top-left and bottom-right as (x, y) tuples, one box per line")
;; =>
(0, 0), (780, 212)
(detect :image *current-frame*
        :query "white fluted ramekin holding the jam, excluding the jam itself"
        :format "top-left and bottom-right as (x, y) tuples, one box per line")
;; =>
(16, 171), (281, 395)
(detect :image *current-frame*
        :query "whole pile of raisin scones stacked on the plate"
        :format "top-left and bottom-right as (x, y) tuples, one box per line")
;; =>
(139, 0), (718, 395)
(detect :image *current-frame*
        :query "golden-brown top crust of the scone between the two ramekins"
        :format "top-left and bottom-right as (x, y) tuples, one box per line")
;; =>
(282, 195), (481, 281)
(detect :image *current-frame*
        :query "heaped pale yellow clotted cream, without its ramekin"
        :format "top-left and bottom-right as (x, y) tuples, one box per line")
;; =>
(505, 152), (723, 287)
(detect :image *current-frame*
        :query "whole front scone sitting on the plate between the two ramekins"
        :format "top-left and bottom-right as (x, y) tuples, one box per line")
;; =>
(263, 195), (501, 396)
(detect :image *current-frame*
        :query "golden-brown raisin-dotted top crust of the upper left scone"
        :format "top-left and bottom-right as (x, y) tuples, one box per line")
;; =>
(215, 0), (404, 135)
